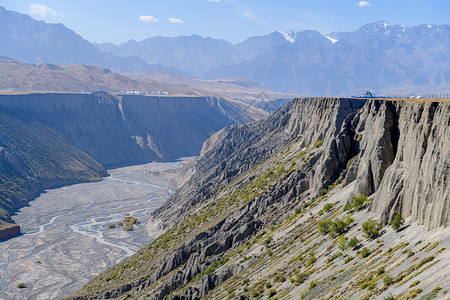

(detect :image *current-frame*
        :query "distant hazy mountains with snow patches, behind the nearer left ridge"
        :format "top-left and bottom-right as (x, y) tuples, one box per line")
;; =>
(97, 22), (450, 95)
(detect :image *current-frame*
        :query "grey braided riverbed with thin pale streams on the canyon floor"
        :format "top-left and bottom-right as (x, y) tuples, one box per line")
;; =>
(0, 162), (185, 299)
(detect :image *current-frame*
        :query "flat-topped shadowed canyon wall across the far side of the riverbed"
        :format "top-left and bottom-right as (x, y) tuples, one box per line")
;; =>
(0, 93), (267, 165)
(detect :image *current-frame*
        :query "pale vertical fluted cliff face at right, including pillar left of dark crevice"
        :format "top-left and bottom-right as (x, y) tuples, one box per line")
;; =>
(347, 101), (450, 229)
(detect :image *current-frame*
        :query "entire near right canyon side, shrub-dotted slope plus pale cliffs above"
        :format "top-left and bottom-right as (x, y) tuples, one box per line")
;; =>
(71, 98), (450, 299)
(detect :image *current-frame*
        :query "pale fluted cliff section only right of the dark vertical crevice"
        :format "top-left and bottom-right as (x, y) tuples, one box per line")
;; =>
(371, 102), (450, 229)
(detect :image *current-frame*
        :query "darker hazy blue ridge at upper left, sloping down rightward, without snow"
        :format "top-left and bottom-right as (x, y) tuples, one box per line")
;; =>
(0, 6), (175, 72)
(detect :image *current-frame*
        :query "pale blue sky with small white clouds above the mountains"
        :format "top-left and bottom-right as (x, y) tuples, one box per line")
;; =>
(0, 0), (450, 44)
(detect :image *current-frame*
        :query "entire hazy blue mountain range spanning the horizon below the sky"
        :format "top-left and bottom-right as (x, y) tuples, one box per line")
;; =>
(0, 7), (450, 96)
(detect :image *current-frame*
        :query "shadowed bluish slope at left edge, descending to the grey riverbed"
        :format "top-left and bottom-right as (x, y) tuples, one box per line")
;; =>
(0, 107), (106, 238)
